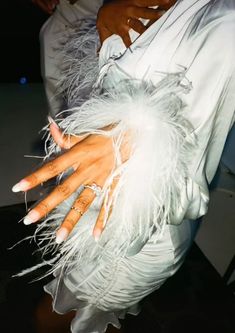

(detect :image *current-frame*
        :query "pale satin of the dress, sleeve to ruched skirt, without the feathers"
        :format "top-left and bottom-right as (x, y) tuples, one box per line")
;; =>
(45, 0), (235, 333)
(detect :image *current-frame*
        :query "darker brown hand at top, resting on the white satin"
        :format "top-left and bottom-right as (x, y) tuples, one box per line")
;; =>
(96, 0), (177, 47)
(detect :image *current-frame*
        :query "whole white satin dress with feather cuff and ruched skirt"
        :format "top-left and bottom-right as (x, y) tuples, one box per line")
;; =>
(28, 0), (235, 333)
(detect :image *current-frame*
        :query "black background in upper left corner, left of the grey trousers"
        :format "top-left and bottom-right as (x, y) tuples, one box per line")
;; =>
(0, 0), (48, 83)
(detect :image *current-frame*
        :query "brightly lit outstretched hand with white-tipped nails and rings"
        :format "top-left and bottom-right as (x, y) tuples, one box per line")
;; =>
(12, 118), (128, 243)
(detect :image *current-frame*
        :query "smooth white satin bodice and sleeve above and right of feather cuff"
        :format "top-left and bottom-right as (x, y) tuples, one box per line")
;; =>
(100, 0), (235, 224)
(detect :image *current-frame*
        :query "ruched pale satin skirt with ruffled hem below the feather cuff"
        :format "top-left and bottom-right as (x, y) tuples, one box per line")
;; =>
(45, 220), (198, 333)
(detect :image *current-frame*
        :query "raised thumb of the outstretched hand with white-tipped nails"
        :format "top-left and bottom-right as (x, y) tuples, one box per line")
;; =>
(48, 117), (88, 149)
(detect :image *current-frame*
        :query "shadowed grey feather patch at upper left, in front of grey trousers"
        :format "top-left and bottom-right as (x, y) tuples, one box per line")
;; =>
(58, 19), (99, 108)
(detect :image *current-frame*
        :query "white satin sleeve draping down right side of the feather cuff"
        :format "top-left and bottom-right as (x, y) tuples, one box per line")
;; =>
(172, 14), (235, 224)
